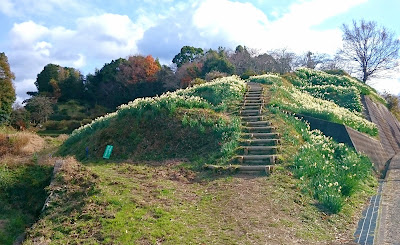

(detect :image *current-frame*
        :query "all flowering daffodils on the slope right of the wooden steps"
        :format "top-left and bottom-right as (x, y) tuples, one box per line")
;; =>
(252, 68), (380, 213)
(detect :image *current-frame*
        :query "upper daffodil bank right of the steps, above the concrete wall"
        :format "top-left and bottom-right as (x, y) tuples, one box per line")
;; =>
(249, 68), (382, 136)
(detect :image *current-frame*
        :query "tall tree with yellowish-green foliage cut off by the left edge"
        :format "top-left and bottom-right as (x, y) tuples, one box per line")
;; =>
(0, 53), (16, 125)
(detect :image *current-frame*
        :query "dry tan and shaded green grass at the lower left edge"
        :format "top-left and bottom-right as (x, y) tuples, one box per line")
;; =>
(0, 128), (66, 244)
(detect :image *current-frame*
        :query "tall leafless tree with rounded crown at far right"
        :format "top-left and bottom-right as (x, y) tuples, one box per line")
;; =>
(339, 20), (400, 83)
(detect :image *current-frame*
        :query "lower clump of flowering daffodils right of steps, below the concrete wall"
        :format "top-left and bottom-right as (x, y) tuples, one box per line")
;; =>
(270, 110), (373, 213)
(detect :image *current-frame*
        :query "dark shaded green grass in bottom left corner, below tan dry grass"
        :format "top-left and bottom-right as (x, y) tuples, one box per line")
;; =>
(0, 163), (52, 245)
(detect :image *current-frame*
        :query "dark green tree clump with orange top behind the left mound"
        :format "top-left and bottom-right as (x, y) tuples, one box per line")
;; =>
(85, 56), (168, 110)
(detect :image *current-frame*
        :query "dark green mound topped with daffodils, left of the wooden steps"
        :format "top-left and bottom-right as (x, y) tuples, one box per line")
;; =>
(59, 76), (245, 163)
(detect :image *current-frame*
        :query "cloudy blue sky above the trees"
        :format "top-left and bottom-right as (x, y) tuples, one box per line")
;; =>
(0, 0), (400, 102)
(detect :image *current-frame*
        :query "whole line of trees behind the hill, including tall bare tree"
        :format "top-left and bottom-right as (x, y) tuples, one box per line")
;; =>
(0, 20), (400, 130)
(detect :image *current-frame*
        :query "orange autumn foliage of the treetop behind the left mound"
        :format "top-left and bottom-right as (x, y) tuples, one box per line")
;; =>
(119, 55), (161, 84)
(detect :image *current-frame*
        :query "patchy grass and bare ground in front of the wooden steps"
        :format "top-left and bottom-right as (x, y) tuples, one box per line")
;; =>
(24, 160), (376, 244)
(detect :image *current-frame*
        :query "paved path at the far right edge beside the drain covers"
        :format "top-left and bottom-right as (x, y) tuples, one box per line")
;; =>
(374, 154), (400, 245)
